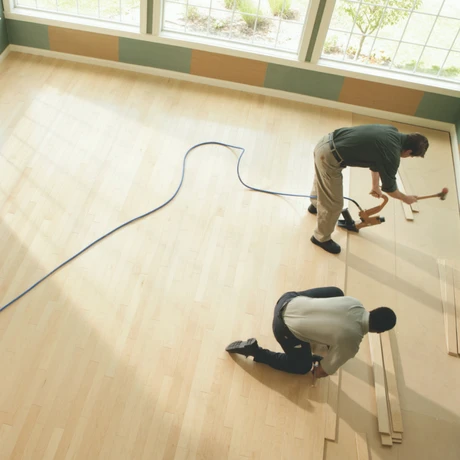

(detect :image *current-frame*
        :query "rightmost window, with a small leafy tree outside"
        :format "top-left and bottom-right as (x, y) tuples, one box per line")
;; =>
(321, 0), (460, 81)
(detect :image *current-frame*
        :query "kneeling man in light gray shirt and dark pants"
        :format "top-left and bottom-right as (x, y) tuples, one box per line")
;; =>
(226, 287), (396, 377)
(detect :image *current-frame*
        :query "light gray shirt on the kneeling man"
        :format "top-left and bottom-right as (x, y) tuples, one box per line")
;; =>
(283, 296), (369, 375)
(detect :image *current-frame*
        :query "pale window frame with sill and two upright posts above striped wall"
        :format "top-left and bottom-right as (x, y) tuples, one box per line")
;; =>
(4, 0), (460, 97)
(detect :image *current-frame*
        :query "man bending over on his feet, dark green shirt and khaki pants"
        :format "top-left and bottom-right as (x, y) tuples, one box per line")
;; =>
(308, 125), (429, 254)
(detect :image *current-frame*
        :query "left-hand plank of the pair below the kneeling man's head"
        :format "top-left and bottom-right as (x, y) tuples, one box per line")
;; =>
(369, 334), (391, 439)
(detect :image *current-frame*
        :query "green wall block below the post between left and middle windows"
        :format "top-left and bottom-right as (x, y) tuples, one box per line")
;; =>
(119, 37), (192, 73)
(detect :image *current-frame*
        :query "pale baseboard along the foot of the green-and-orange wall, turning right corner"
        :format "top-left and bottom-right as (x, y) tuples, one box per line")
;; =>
(5, 45), (460, 202)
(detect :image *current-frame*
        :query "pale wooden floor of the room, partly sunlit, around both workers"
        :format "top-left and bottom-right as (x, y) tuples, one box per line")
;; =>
(0, 53), (460, 460)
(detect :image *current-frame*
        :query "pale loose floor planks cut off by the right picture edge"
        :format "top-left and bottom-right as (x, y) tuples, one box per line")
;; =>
(438, 259), (458, 356)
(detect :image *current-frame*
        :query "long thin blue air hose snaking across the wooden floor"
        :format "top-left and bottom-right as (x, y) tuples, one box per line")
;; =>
(0, 141), (361, 312)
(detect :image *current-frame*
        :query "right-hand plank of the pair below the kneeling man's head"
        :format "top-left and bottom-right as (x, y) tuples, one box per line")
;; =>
(380, 331), (403, 433)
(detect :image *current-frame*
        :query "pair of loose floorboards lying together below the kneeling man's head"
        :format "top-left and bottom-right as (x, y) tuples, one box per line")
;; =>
(369, 331), (403, 446)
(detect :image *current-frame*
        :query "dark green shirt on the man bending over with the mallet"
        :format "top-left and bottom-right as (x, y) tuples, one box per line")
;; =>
(333, 125), (407, 193)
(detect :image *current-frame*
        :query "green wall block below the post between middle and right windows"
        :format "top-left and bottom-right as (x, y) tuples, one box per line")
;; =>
(264, 64), (344, 101)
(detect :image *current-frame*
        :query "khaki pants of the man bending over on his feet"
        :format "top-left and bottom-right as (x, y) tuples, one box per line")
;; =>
(311, 135), (343, 243)
